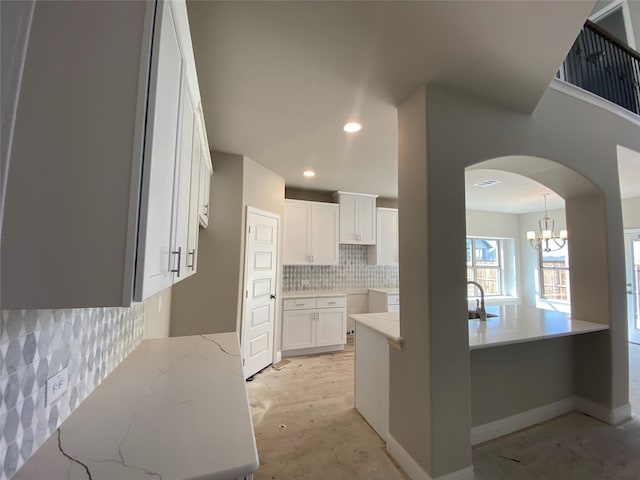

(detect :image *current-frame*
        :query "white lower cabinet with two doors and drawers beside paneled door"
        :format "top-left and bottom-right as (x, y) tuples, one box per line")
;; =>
(282, 295), (347, 356)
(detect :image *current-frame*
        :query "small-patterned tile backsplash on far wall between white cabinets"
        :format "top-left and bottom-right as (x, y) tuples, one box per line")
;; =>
(282, 245), (399, 292)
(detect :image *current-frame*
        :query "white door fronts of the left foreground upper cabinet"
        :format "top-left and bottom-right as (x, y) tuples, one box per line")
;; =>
(134, 2), (208, 300)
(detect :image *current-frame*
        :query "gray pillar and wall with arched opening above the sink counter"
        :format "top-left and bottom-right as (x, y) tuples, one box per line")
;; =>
(389, 81), (640, 476)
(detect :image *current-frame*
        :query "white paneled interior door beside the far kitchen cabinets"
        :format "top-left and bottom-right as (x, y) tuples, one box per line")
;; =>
(241, 207), (279, 378)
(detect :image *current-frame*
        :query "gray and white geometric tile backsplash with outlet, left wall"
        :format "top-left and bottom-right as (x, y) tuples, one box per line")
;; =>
(0, 303), (144, 480)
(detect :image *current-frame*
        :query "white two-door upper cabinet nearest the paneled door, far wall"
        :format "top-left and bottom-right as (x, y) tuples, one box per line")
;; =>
(282, 200), (339, 265)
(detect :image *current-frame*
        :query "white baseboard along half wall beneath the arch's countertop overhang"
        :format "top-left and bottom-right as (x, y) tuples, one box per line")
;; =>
(471, 397), (576, 445)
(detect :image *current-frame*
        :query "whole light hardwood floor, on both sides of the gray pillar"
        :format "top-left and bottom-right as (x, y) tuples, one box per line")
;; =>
(247, 343), (640, 480)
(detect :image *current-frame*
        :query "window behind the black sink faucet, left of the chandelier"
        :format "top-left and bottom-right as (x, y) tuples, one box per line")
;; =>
(467, 238), (502, 297)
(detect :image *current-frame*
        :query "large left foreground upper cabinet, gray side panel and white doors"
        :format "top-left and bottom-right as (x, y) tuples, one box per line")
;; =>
(0, 1), (208, 309)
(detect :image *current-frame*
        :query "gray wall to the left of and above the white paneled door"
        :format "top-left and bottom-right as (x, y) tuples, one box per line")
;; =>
(171, 152), (284, 347)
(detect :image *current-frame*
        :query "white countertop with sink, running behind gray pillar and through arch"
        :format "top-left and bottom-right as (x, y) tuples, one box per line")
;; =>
(349, 305), (609, 350)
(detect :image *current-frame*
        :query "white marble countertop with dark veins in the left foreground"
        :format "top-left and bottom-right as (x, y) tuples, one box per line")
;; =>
(13, 333), (258, 480)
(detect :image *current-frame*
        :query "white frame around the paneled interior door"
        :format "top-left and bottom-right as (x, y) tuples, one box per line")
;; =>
(238, 205), (282, 376)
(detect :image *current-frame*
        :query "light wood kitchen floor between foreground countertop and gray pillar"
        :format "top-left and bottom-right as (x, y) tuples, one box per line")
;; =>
(247, 342), (408, 480)
